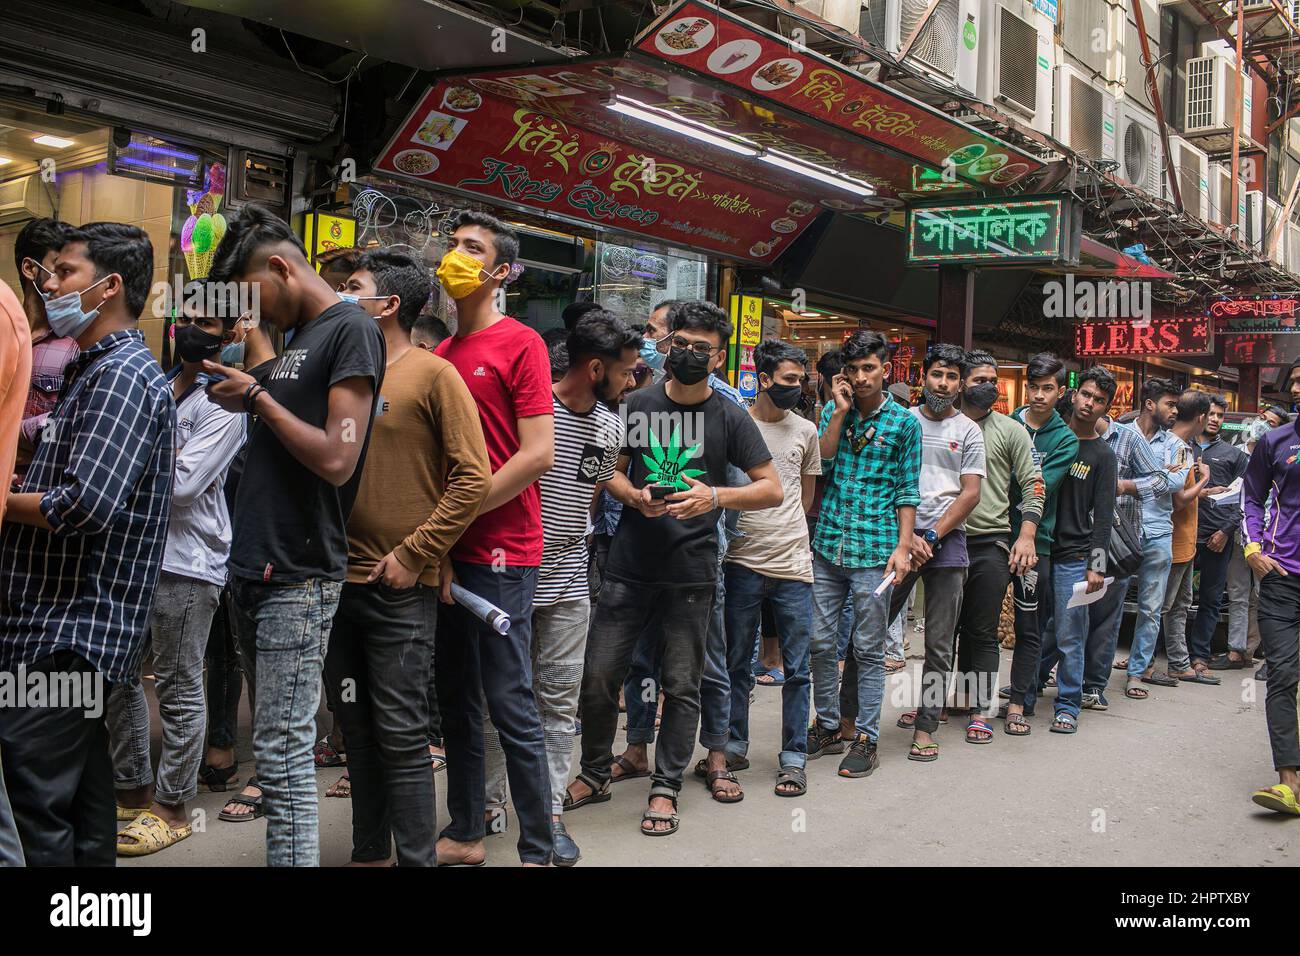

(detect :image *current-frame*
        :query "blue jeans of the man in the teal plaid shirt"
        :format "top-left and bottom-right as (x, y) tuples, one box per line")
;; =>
(813, 553), (892, 743)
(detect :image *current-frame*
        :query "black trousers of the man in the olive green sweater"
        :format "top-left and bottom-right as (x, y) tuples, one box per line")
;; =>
(957, 535), (1011, 711)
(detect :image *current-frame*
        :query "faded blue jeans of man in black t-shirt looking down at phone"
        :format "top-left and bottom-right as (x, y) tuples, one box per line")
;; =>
(230, 578), (343, 866)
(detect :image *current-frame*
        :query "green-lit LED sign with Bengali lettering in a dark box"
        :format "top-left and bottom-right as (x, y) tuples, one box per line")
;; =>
(906, 196), (1082, 265)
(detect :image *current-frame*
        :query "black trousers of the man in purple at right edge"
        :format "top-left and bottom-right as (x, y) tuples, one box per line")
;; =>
(1253, 571), (1300, 773)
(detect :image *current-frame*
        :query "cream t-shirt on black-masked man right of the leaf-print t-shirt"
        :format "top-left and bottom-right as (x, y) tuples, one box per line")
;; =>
(727, 411), (822, 581)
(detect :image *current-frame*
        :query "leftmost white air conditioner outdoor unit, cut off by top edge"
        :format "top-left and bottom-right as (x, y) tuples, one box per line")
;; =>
(858, 0), (979, 96)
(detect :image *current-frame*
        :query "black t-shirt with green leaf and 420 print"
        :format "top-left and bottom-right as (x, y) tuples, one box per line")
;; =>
(606, 384), (772, 585)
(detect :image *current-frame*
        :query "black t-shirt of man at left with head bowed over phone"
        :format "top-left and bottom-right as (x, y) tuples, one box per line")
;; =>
(230, 302), (386, 584)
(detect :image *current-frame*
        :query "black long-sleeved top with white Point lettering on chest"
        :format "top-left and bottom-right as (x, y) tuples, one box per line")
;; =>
(1052, 438), (1118, 574)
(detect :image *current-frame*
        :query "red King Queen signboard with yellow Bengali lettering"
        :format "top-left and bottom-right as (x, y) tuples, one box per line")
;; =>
(374, 81), (818, 261)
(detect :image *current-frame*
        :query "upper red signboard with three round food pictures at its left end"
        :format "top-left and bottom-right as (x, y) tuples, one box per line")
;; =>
(636, 0), (1043, 189)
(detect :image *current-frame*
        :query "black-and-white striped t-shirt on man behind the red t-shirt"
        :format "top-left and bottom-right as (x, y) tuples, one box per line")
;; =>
(533, 393), (623, 607)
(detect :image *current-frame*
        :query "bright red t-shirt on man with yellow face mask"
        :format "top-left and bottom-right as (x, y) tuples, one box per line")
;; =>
(434, 316), (554, 567)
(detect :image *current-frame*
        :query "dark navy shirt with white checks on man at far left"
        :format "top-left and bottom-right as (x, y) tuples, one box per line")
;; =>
(0, 329), (176, 682)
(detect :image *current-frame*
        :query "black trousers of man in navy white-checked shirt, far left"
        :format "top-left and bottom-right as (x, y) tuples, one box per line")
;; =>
(0, 650), (117, 866)
